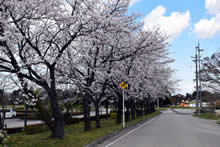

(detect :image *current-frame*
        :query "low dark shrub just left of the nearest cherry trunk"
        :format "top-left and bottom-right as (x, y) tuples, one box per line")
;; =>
(24, 124), (48, 134)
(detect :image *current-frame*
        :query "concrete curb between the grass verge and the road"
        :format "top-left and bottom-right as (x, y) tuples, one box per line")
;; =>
(84, 112), (161, 147)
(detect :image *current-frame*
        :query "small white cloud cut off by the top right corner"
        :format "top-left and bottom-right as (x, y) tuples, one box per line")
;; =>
(205, 0), (220, 14)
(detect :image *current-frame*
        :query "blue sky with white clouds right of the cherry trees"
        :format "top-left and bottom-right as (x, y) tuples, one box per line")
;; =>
(129, 0), (220, 94)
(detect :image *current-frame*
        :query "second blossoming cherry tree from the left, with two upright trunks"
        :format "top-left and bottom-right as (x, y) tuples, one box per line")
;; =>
(56, 0), (140, 130)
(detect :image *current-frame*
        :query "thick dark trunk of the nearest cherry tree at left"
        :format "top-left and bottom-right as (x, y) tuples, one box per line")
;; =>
(48, 66), (64, 139)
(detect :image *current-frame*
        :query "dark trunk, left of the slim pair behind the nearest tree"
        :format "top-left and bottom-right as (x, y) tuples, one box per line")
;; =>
(83, 94), (91, 131)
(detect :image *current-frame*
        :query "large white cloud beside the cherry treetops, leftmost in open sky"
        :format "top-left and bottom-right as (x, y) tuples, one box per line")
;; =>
(144, 6), (190, 40)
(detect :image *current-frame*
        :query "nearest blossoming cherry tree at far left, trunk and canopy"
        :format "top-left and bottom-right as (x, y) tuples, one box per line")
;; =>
(0, 0), (114, 138)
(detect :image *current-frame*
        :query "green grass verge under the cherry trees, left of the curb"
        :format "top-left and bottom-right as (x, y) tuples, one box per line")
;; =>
(7, 111), (160, 147)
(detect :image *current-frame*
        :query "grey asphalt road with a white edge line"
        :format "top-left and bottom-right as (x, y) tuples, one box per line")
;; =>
(99, 109), (220, 147)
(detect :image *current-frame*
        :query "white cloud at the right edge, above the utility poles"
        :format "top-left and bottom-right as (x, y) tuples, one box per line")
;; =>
(194, 13), (220, 39)
